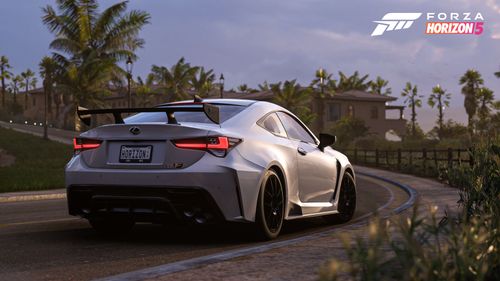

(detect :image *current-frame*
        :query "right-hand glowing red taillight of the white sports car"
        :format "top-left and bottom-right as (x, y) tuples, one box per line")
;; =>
(172, 137), (241, 157)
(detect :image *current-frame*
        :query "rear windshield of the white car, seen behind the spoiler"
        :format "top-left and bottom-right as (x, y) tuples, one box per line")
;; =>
(124, 104), (246, 124)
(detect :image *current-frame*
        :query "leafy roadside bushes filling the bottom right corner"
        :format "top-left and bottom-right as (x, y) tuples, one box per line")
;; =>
(319, 144), (500, 281)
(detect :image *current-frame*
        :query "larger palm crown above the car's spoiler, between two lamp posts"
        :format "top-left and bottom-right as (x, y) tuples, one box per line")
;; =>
(151, 57), (198, 101)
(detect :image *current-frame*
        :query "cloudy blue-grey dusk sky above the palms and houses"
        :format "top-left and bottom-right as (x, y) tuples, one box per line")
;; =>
(0, 0), (500, 130)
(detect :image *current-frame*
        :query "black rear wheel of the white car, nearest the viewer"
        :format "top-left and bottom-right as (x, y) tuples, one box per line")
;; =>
(255, 170), (285, 240)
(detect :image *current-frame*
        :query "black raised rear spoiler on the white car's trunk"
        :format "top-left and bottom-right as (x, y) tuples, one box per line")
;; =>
(76, 102), (220, 126)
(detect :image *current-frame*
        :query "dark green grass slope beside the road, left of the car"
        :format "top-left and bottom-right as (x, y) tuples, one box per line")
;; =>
(0, 128), (73, 192)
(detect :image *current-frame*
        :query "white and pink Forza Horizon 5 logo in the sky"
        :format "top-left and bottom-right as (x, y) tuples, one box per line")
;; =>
(371, 13), (484, 36)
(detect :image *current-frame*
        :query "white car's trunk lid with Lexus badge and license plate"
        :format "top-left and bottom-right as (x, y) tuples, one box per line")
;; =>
(81, 123), (219, 169)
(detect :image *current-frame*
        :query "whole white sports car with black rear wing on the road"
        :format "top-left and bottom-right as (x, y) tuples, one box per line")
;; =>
(66, 97), (356, 239)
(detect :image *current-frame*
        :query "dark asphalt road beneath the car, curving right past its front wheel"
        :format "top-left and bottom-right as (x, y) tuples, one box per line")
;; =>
(0, 176), (408, 280)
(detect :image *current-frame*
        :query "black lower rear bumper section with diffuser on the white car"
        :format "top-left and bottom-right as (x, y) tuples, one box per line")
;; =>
(67, 186), (224, 224)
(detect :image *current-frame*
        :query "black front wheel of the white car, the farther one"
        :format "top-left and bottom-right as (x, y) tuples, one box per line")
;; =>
(323, 173), (356, 223)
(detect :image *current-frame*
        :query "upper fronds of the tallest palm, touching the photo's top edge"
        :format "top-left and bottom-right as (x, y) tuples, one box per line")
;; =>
(42, 0), (150, 62)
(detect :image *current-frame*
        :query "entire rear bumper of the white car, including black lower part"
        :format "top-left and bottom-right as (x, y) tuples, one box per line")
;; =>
(65, 153), (263, 221)
